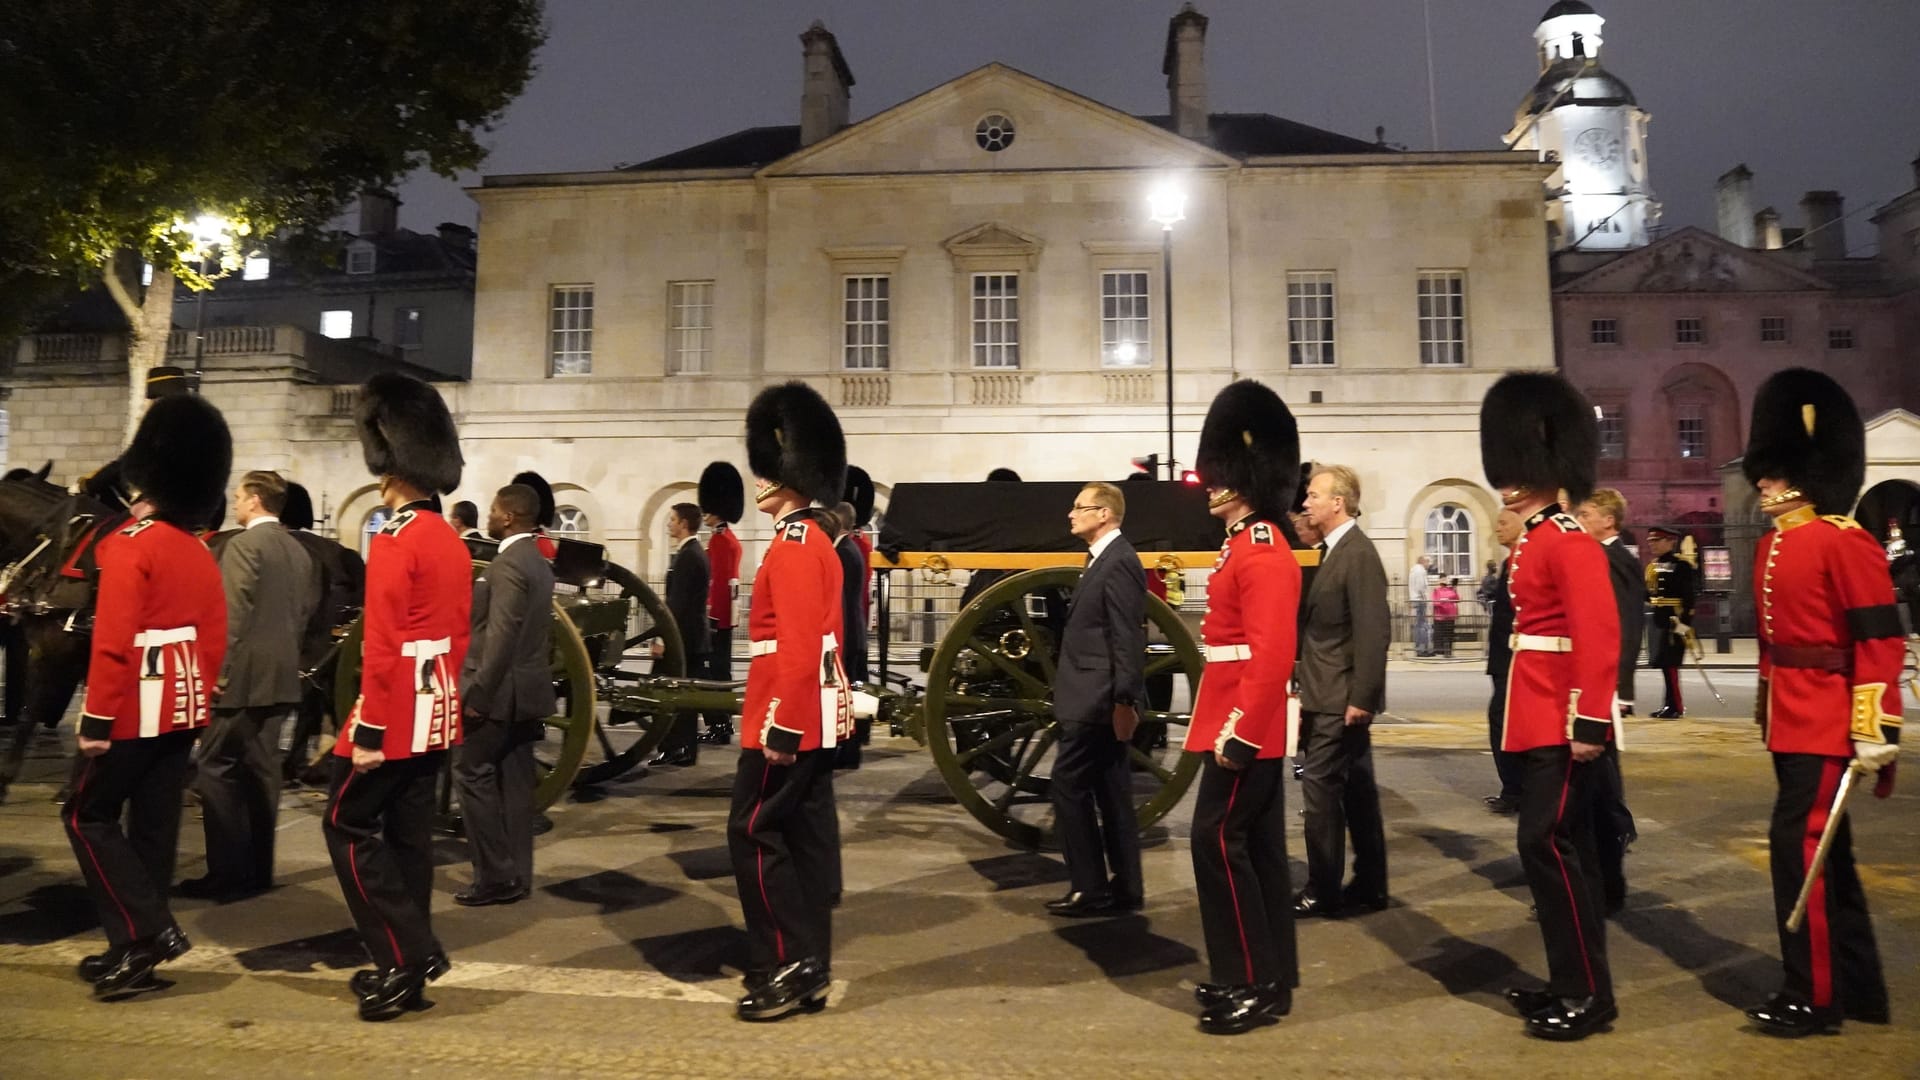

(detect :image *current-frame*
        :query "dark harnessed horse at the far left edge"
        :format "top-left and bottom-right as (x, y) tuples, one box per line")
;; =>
(0, 463), (127, 801)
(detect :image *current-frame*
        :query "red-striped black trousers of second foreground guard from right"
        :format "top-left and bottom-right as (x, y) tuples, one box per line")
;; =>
(1517, 746), (1613, 1001)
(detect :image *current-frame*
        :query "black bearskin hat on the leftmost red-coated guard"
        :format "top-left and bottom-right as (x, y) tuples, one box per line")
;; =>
(121, 394), (234, 527)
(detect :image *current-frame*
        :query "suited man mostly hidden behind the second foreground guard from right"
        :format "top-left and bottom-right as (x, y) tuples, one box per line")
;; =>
(1574, 488), (1647, 915)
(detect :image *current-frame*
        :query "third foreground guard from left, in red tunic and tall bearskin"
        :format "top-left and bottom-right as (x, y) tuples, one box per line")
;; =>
(728, 382), (852, 1020)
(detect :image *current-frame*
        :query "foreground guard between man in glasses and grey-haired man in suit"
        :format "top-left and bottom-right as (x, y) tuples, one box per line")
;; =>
(1187, 379), (1300, 1036)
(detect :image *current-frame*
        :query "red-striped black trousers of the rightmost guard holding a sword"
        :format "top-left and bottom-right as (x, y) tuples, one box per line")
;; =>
(1766, 753), (1887, 1017)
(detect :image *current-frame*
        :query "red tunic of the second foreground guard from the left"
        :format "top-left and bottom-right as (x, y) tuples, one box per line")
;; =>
(334, 502), (472, 761)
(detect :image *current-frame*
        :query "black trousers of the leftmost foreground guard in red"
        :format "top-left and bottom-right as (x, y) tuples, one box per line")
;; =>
(60, 730), (196, 947)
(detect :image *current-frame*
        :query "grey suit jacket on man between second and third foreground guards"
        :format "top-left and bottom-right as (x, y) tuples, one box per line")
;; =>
(461, 538), (557, 723)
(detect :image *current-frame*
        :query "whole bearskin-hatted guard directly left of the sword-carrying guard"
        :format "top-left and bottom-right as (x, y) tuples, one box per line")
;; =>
(1480, 373), (1620, 1042)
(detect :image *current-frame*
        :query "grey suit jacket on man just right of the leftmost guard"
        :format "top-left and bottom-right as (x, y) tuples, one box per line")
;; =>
(217, 521), (319, 709)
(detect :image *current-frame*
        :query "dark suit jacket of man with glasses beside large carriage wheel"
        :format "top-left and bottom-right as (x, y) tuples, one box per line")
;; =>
(1054, 534), (1146, 724)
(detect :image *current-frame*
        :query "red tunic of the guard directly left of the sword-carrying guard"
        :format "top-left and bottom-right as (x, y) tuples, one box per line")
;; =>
(1500, 505), (1620, 751)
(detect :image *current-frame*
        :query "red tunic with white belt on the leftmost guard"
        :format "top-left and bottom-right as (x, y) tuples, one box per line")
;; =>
(81, 517), (227, 740)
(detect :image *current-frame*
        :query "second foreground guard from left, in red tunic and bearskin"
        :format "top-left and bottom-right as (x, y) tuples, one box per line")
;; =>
(323, 373), (472, 1020)
